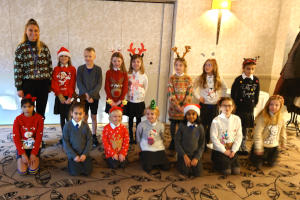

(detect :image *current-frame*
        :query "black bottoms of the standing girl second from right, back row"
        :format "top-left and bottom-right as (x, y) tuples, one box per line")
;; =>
(200, 103), (218, 144)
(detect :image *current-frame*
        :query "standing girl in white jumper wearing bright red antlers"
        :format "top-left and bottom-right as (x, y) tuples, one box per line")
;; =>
(125, 43), (148, 144)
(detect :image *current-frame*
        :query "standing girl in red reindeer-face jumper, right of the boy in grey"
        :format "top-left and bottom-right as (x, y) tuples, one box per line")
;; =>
(105, 52), (128, 113)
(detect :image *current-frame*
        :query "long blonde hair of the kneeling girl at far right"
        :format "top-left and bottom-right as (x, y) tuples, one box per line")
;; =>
(257, 95), (284, 125)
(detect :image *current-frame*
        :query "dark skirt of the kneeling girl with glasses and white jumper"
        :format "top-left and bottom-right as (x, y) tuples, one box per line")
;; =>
(211, 150), (240, 171)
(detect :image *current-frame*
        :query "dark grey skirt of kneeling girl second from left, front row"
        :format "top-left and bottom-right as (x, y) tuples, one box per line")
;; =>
(68, 156), (93, 176)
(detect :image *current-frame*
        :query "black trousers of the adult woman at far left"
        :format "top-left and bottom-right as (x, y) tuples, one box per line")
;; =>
(22, 79), (50, 118)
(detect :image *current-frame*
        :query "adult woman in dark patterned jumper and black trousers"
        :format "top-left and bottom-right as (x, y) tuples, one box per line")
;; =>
(14, 19), (52, 117)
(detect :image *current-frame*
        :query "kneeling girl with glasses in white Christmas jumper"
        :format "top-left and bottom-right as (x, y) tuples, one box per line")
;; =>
(210, 97), (243, 175)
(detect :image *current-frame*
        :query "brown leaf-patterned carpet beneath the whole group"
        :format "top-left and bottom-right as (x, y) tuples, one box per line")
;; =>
(0, 126), (300, 200)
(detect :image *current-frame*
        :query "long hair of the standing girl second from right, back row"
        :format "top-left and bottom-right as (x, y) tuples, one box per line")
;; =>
(199, 58), (221, 90)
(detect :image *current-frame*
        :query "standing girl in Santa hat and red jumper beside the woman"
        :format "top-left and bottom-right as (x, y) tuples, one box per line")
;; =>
(51, 47), (76, 130)
